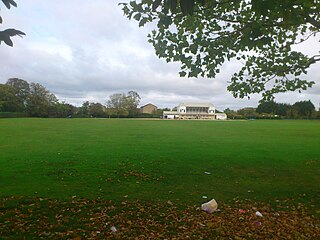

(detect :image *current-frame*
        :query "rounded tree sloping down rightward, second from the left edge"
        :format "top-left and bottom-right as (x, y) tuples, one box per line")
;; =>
(27, 83), (58, 117)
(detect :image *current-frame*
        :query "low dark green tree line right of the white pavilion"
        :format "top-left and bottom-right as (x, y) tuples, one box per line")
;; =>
(224, 100), (320, 119)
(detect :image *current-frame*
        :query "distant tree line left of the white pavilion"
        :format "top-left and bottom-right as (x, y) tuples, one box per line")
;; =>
(0, 78), (159, 118)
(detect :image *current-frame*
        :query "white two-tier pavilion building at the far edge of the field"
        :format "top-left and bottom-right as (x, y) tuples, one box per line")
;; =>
(163, 103), (227, 119)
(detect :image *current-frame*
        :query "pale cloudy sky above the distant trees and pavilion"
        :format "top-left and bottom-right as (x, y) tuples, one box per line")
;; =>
(0, 0), (320, 110)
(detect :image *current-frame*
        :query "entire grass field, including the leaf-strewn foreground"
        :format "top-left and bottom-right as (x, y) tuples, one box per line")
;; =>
(0, 119), (320, 239)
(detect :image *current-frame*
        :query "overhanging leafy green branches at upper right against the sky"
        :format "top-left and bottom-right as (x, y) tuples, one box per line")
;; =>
(121, 0), (320, 100)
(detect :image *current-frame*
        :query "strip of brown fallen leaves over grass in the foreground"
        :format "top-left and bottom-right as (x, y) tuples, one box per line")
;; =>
(0, 197), (320, 239)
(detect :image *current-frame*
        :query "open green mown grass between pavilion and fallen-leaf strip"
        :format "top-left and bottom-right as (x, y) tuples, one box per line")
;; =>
(0, 119), (320, 204)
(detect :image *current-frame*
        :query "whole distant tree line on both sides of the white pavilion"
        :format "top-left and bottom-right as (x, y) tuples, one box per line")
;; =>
(0, 78), (320, 119)
